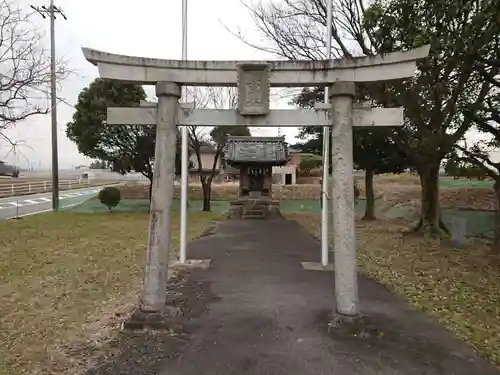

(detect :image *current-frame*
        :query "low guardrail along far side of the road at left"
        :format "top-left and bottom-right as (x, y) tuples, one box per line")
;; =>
(0, 180), (95, 198)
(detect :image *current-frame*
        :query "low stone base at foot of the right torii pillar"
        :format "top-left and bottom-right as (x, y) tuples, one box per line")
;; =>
(328, 312), (383, 339)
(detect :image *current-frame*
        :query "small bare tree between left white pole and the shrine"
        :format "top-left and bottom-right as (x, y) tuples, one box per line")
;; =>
(188, 87), (250, 211)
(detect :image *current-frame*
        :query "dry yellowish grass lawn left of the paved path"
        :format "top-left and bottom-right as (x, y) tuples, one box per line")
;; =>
(0, 212), (219, 375)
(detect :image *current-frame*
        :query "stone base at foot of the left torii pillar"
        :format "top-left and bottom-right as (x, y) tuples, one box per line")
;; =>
(122, 306), (182, 331)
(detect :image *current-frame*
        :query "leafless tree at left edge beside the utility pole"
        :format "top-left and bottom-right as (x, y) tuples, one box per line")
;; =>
(0, 0), (68, 138)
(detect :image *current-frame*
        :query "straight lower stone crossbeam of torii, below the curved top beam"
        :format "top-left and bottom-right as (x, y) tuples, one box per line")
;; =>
(107, 106), (403, 127)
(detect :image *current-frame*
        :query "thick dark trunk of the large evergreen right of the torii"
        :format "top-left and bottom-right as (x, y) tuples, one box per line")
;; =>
(415, 162), (449, 234)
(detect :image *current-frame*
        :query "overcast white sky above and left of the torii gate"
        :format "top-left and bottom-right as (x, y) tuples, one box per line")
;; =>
(0, 0), (298, 169)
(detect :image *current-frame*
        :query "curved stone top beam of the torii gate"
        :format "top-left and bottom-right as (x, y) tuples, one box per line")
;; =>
(82, 45), (429, 87)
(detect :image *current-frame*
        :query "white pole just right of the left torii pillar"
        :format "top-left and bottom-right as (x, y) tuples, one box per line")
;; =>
(179, 0), (189, 264)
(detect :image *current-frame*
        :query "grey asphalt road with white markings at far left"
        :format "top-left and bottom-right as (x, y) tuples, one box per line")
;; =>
(0, 186), (103, 220)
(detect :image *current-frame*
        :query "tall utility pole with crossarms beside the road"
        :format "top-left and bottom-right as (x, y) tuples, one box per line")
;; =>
(31, 0), (67, 212)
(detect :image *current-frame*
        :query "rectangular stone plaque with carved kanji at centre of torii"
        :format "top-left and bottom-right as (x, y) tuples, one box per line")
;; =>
(238, 64), (269, 116)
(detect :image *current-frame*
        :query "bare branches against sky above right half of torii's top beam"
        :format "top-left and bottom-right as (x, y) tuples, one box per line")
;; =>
(231, 0), (368, 60)
